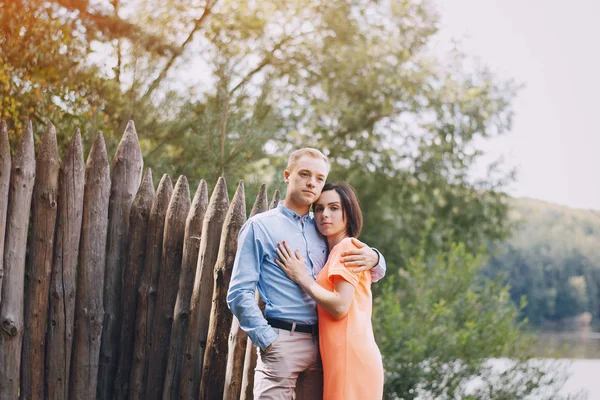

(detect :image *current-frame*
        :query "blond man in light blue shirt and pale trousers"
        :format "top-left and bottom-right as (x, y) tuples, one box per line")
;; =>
(227, 148), (385, 400)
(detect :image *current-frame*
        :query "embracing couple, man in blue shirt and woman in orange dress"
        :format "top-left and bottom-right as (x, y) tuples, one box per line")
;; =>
(227, 148), (385, 400)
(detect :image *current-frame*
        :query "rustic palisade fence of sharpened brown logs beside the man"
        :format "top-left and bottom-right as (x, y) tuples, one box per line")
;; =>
(0, 121), (279, 400)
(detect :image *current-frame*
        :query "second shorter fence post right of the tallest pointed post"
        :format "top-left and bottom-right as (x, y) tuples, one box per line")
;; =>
(129, 174), (173, 400)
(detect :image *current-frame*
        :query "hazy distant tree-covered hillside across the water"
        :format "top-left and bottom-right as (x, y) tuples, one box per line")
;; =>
(485, 199), (600, 324)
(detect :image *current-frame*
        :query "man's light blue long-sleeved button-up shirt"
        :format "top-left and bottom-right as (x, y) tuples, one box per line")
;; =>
(227, 202), (386, 349)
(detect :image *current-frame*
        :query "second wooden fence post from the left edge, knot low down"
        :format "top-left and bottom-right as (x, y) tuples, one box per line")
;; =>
(0, 121), (35, 400)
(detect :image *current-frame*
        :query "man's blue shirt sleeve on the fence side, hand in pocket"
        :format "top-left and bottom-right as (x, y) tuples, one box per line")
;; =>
(227, 220), (278, 350)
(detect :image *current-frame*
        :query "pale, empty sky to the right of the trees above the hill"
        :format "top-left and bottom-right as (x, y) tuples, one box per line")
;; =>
(436, 0), (600, 210)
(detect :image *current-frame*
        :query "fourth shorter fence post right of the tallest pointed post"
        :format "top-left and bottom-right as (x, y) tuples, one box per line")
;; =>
(163, 179), (208, 400)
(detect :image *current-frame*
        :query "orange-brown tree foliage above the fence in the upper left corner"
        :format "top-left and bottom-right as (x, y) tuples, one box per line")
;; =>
(0, 0), (172, 151)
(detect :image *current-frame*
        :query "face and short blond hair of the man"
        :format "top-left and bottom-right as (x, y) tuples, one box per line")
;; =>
(283, 155), (328, 205)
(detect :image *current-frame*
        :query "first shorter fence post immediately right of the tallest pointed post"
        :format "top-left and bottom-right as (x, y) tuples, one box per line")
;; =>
(113, 168), (154, 400)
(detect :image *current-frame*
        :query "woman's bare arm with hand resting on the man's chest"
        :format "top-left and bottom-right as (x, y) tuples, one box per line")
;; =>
(275, 242), (354, 319)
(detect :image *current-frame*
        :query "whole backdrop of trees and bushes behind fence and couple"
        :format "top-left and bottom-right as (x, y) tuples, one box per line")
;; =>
(0, 0), (597, 398)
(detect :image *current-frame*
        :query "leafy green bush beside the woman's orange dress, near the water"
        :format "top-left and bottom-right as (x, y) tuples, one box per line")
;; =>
(374, 244), (584, 400)
